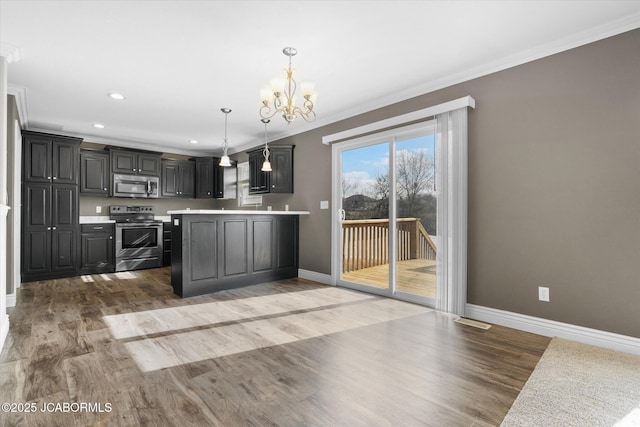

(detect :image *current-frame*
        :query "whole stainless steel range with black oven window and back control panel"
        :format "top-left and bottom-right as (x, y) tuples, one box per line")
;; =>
(109, 205), (162, 271)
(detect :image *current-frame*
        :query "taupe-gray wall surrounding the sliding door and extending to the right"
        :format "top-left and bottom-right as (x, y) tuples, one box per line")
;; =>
(238, 30), (640, 337)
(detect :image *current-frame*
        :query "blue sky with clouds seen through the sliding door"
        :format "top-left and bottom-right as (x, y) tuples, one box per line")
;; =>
(342, 134), (435, 195)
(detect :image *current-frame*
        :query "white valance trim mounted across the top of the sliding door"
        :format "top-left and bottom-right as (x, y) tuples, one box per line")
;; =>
(322, 96), (476, 145)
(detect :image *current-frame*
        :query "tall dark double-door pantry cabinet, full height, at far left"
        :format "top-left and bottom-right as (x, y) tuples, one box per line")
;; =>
(22, 131), (82, 282)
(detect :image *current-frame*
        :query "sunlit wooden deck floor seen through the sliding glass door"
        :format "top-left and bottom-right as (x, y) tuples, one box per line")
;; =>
(342, 259), (436, 298)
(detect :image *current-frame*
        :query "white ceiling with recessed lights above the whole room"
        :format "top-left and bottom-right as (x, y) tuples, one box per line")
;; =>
(0, 0), (640, 155)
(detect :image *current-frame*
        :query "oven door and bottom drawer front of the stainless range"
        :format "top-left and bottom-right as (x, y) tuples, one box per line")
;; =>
(116, 223), (162, 271)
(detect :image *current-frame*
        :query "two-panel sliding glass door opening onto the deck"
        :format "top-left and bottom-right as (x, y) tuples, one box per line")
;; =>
(334, 122), (438, 306)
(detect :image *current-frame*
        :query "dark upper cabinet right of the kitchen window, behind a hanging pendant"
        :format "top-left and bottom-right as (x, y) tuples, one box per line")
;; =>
(248, 145), (294, 194)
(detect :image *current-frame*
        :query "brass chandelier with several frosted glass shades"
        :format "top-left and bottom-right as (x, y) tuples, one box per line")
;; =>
(260, 47), (316, 124)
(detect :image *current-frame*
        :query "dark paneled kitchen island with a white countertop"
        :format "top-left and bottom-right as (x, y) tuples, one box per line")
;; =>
(167, 210), (309, 297)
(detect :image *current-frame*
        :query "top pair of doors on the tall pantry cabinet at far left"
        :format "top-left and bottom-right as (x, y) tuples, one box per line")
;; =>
(22, 131), (82, 185)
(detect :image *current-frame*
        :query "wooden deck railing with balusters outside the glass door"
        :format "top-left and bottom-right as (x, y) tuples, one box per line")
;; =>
(342, 218), (436, 273)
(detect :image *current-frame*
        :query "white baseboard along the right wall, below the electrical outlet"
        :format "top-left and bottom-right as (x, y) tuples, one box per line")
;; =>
(465, 304), (640, 355)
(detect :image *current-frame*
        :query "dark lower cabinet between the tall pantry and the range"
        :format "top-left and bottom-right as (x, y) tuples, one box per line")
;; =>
(80, 223), (115, 274)
